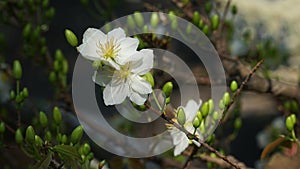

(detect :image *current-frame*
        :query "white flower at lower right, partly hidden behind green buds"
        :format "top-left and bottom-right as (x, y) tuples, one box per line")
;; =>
(168, 100), (202, 156)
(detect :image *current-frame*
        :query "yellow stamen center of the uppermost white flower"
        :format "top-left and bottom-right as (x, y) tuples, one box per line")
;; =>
(97, 38), (120, 59)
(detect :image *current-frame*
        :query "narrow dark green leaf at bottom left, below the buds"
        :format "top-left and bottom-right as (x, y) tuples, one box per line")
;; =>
(53, 145), (81, 160)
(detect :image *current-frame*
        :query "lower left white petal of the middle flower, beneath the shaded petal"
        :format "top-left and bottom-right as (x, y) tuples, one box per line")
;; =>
(103, 78), (129, 106)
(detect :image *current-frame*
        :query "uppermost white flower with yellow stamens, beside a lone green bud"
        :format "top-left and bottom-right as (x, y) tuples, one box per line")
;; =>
(77, 28), (139, 69)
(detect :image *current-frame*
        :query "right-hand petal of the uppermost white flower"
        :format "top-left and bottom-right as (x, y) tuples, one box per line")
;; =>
(116, 37), (139, 65)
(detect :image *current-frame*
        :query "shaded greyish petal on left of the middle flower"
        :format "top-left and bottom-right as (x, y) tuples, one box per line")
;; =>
(93, 66), (114, 86)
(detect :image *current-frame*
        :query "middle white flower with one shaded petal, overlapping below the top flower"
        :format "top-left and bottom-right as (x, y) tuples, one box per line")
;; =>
(93, 49), (153, 105)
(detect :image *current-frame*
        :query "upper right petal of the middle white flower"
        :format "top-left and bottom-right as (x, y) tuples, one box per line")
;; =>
(131, 49), (154, 75)
